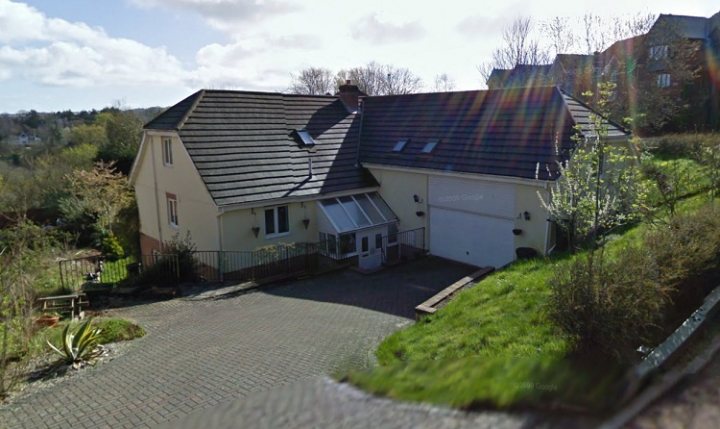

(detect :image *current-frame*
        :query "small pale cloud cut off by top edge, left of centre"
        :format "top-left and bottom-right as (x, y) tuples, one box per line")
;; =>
(132, 0), (302, 33)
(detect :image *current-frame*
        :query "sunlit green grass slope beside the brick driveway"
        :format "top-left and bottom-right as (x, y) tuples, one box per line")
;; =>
(348, 196), (707, 409)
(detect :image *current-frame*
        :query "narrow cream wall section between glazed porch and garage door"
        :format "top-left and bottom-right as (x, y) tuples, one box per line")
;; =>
(369, 168), (428, 241)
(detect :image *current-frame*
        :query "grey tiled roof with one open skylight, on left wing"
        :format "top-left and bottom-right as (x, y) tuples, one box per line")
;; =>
(145, 90), (377, 206)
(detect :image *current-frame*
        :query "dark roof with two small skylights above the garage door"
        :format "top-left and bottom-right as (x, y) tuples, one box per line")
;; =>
(360, 87), (627, 180)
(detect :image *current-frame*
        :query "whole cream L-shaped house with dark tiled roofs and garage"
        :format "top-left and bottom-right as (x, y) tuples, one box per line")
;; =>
(130, 84), (627, 269)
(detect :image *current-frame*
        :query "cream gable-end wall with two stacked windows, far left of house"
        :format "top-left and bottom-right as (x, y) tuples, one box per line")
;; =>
(135, 133), (220, 250)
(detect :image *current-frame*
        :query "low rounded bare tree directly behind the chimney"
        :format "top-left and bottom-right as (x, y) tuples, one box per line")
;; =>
(336, 61), (422, 95)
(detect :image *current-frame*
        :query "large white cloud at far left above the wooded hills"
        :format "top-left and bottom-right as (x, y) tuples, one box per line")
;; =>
(0, 0), (190, 87)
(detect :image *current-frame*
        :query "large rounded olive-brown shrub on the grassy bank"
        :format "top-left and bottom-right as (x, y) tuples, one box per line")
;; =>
(549, 246), (670, 361)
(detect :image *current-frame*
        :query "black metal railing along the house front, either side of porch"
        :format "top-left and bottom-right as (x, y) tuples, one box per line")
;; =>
(59, 228), (425, 291)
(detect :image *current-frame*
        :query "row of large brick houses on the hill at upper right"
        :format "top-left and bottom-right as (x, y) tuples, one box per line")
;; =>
(487, 12), (720, 129)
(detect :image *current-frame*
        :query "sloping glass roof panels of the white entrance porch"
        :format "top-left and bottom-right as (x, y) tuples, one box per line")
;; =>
(320, 192), (397, 233)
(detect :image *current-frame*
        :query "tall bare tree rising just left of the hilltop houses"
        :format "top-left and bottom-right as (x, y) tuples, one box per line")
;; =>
(477, 17), (550, 82)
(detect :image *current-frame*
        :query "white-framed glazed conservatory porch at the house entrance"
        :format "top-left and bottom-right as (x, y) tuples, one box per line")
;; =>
(318, 192), (398, 270)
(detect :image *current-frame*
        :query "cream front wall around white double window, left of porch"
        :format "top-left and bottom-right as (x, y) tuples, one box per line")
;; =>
(220, 201), (318, 250)
